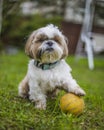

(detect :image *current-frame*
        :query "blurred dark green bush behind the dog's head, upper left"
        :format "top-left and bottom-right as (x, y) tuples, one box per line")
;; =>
(2, 14), (62, 47)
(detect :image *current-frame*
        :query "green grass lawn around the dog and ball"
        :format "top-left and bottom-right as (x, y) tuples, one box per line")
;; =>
(0, 52), (104, 130)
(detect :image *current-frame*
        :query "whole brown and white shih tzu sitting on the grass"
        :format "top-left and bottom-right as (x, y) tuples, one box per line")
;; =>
(18, 24), (85, 109)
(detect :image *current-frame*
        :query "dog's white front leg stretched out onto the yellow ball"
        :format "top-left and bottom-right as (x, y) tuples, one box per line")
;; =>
(62, 78), (85, 96)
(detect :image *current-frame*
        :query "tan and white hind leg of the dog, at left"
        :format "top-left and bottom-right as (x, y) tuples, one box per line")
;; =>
(18, 75), (29, 98)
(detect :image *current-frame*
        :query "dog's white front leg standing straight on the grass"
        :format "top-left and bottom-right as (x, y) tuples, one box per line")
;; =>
(29, 85), (46, 110)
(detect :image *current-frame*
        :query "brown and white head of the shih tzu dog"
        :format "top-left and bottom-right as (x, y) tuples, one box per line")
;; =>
(25, 24), (68, 63)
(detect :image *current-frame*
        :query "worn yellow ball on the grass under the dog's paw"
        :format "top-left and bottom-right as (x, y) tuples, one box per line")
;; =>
(60, 93), (85, 115)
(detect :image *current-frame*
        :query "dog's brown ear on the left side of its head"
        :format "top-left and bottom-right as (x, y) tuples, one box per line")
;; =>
(25, 31), (36, 58)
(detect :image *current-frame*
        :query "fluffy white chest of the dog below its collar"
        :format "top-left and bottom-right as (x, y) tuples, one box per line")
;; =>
(28, 61), (69, 91)
